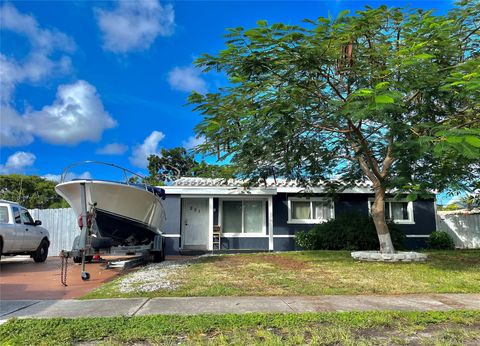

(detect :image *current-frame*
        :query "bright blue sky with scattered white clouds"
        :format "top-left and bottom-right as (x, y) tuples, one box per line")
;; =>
(0, 0), (452, 200)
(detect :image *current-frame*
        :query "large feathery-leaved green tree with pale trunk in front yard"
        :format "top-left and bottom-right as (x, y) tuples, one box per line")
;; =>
(189, 1), (480, 253)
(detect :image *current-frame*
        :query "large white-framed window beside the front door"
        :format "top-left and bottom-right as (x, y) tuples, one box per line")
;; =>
(221, 201), (265, 234)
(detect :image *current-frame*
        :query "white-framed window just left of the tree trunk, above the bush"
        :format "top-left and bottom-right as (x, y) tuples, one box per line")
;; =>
(288, 198), (335, 223)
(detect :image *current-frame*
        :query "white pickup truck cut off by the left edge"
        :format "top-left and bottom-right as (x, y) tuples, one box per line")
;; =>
(0, 200), (50, 262)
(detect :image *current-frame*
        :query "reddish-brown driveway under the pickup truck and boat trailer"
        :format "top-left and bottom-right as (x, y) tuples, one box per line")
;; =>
(0, 256), (122, 300)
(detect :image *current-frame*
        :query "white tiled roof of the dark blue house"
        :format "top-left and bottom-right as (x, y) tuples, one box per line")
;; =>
(162, 177), (373, 195)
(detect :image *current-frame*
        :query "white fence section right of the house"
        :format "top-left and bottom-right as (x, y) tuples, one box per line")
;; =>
(437, 213), (480, 249)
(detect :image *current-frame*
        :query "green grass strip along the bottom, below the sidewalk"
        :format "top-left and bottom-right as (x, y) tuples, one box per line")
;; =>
(0, 310), (480, 345)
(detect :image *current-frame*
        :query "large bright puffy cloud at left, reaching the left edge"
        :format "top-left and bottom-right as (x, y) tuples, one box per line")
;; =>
(0, 81), (117, 146)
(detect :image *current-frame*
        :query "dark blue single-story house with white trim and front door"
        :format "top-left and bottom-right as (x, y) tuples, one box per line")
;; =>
(159, 177), (436, 254)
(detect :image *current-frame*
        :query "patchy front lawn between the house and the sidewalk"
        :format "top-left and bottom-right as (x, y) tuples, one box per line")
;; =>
(84, 250), (480, 299)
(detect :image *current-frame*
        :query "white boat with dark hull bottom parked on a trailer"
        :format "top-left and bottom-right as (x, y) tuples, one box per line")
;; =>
(55, 161), (165, 246)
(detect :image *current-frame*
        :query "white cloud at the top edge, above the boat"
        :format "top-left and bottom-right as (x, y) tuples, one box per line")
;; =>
(95, 0), (175, 53)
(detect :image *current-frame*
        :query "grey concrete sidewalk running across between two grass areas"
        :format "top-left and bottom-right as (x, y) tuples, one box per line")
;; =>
(0, 294), (480, 322)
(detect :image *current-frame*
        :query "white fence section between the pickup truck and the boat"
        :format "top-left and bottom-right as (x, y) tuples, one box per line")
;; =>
(29, 208), (80, 256)
